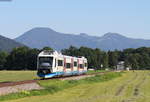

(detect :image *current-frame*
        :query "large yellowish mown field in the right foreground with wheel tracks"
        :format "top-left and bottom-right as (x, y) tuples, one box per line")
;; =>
(2, 71), (150, 102)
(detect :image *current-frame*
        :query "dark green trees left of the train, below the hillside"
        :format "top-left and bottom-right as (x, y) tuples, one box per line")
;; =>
(0, 47), (53, 70)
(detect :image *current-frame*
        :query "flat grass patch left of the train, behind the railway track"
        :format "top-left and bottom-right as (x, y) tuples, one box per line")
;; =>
(0, 71), (37, 82)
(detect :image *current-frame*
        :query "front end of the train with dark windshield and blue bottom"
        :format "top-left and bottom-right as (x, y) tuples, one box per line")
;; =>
(37, 51), (56, 78)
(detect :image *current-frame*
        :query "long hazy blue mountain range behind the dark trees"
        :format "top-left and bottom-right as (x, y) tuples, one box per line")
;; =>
(15, 27), (150, 51)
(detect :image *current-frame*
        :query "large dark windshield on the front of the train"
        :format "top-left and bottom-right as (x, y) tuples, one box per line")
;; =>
(39, 57), (53, 69)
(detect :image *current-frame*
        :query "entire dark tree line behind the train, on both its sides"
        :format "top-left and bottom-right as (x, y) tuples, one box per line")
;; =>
(0, 46), (150, 70)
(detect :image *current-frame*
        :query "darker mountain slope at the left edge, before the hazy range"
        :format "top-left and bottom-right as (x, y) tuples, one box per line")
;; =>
(0, 35), (25, 52)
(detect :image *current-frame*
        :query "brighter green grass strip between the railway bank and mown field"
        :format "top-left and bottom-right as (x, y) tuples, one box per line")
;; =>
(0, 72), (123, 101)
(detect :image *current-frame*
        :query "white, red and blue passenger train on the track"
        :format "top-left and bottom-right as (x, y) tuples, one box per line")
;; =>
(37, 50), (88, 78)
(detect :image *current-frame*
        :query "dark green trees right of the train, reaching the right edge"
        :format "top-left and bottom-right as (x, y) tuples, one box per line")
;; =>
(62, 46), (150, 70)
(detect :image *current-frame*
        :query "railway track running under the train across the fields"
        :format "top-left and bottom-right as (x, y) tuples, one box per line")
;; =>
(0, 71), (111, 88)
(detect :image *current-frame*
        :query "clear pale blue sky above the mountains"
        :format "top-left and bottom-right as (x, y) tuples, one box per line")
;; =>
(0, 0), (150, 39)
